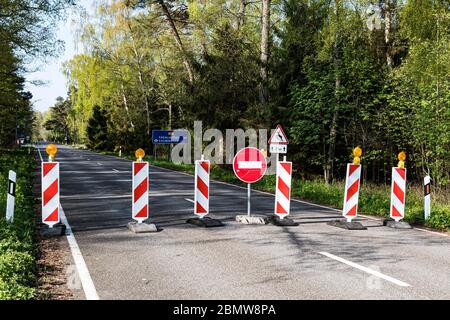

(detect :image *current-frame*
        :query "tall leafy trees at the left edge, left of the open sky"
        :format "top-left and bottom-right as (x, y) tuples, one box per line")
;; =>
(0, 0), (73, 147)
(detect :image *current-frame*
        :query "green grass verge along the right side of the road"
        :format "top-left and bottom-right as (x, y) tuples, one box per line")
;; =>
(96, 152), (450, 230)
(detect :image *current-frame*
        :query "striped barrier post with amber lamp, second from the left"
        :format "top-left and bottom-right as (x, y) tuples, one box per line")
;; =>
(132, 149), (149, 223)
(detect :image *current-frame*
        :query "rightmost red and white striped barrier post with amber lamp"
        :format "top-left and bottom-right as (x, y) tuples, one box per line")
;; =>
(390, 152), (406, 222)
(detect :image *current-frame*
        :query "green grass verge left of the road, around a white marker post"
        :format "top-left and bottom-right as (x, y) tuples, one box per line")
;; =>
(0, 149), (36, 300)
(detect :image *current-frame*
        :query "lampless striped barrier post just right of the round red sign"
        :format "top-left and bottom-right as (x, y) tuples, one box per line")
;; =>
(275, 157), (292, 219)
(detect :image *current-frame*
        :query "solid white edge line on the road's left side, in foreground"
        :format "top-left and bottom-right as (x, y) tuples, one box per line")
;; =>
(60, 206), (99, 300)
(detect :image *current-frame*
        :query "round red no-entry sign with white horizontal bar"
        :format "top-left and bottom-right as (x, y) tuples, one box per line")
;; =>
(233, 147), (267, 183)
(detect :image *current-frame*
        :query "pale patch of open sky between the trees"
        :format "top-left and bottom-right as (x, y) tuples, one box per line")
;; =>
(26, 0), (94, 112)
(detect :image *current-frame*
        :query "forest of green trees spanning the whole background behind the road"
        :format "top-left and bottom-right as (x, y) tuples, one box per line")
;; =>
(0, 0), (450, 189)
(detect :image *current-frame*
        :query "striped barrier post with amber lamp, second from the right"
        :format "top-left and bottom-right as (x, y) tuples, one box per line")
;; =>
(342, 147), (362, 222)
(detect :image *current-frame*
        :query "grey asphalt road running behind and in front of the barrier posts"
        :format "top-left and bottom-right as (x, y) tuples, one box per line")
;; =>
(39, 145), (450, 299)
